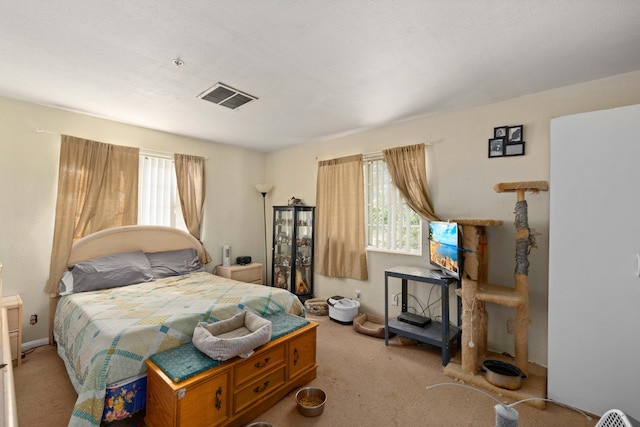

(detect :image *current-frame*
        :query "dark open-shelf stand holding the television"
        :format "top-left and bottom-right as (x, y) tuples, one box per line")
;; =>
(384, 266), (462, 366)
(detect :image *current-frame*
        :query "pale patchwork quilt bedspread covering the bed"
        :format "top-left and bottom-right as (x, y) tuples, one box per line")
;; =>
(53, 272), (304, 426)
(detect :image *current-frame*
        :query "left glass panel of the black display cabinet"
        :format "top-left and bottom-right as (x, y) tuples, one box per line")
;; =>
(273, 209), (294, 289)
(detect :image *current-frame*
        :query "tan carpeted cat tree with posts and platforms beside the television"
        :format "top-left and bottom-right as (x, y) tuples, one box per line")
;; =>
(444, 181), (548, 409)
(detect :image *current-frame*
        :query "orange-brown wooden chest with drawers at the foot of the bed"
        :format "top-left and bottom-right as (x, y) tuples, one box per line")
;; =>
(145, 322), (318, 427)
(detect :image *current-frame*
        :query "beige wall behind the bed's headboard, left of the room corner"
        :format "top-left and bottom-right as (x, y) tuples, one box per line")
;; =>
(0, 98), (265, 342)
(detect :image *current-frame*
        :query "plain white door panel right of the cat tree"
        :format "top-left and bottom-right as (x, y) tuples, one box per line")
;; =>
(548, 105), (640, 418)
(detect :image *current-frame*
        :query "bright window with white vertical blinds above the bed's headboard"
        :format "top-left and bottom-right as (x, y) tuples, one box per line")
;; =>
(138, 152), (187, 231)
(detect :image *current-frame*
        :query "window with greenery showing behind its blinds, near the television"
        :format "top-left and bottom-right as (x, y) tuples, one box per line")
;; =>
(364, 156), (422, 255)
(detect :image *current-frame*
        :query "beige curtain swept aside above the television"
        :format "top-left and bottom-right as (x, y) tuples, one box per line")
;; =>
(382, 144), (439, 221)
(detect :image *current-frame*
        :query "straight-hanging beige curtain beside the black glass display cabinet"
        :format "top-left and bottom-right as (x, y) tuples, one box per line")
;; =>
(315, 155), (368, 280)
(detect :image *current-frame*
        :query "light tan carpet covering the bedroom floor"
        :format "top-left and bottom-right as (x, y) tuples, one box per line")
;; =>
(14, 316), (597, 427)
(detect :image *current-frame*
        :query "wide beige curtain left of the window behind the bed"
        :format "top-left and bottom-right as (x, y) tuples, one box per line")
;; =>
(45, 135), (139, 294)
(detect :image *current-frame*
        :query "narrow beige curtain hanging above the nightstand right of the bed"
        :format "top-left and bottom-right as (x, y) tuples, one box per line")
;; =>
(173, 150), (211, 265)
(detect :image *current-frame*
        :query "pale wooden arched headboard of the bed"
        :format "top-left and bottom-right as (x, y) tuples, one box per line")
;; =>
(49, 225), (205, 345)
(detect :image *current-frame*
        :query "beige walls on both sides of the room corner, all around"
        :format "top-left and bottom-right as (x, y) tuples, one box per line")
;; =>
(0, 72), (640, 364)
